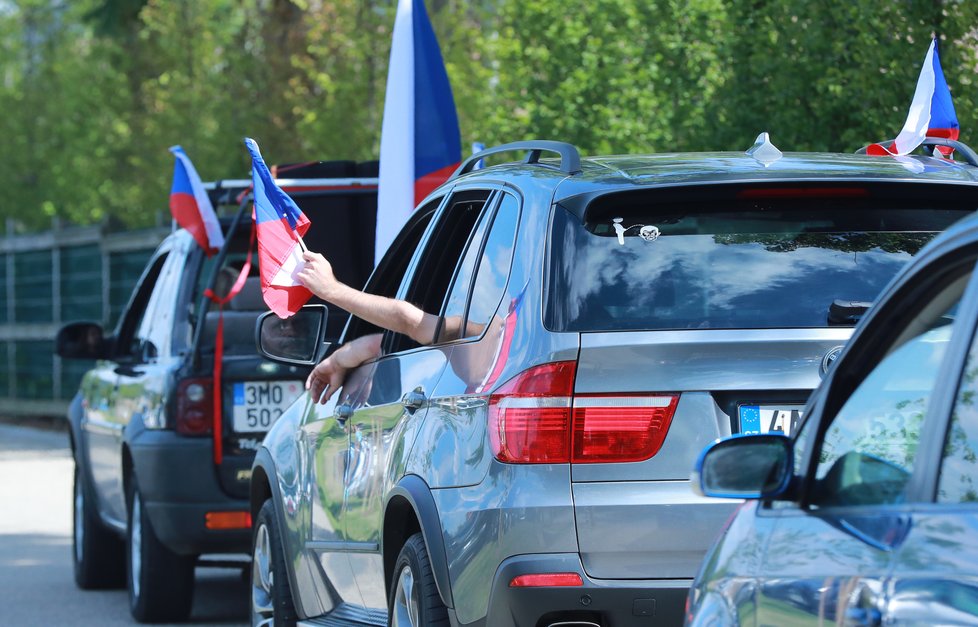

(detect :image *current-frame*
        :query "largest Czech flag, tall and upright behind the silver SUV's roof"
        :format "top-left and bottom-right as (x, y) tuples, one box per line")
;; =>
(374, 0), (462, 263)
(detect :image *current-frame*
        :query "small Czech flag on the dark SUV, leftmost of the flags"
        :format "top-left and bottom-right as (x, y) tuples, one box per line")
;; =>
(170, 146), (224, 256)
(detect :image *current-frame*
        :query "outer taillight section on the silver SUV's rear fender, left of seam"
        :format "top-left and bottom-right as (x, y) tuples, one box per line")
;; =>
(489, 361), (577, 464)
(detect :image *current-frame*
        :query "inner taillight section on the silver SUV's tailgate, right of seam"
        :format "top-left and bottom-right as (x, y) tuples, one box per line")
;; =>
(572, 394), (679, 464)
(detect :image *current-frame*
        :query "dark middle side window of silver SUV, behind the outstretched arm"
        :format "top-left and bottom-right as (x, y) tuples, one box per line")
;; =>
(385, 190), (491, 353)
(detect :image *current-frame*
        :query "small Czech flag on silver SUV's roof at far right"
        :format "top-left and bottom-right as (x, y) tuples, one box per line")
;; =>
(867, 38), (959, 156)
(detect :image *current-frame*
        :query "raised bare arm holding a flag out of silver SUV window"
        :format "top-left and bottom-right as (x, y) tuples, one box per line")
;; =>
(298, 251), (438, 344)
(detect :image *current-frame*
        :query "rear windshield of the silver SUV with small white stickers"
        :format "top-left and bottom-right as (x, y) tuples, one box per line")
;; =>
(546, 198), (969, 331)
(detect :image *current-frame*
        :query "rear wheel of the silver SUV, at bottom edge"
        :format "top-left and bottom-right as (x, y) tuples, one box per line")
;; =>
(387, 533), (449, 627)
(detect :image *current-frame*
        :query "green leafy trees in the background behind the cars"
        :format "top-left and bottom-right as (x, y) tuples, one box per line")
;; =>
(0, 0), (978, 229)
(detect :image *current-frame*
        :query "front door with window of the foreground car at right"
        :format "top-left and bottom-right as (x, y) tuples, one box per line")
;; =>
(756, 247), (974, 625)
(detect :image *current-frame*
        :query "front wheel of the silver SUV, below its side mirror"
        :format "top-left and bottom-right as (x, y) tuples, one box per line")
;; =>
(251, 499), (298, 627)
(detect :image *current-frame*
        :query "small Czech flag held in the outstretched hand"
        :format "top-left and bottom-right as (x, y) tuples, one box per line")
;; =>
(245, 138), (312, 318)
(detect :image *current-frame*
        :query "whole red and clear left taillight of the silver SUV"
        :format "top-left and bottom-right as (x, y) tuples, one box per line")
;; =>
(489, 361), (679, 464)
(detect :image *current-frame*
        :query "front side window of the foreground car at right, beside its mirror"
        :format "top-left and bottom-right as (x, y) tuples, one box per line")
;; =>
(811, 272), (970, 507)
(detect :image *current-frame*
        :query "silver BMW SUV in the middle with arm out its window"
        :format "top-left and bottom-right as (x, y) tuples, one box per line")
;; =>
(251, 136), (978, 627)
